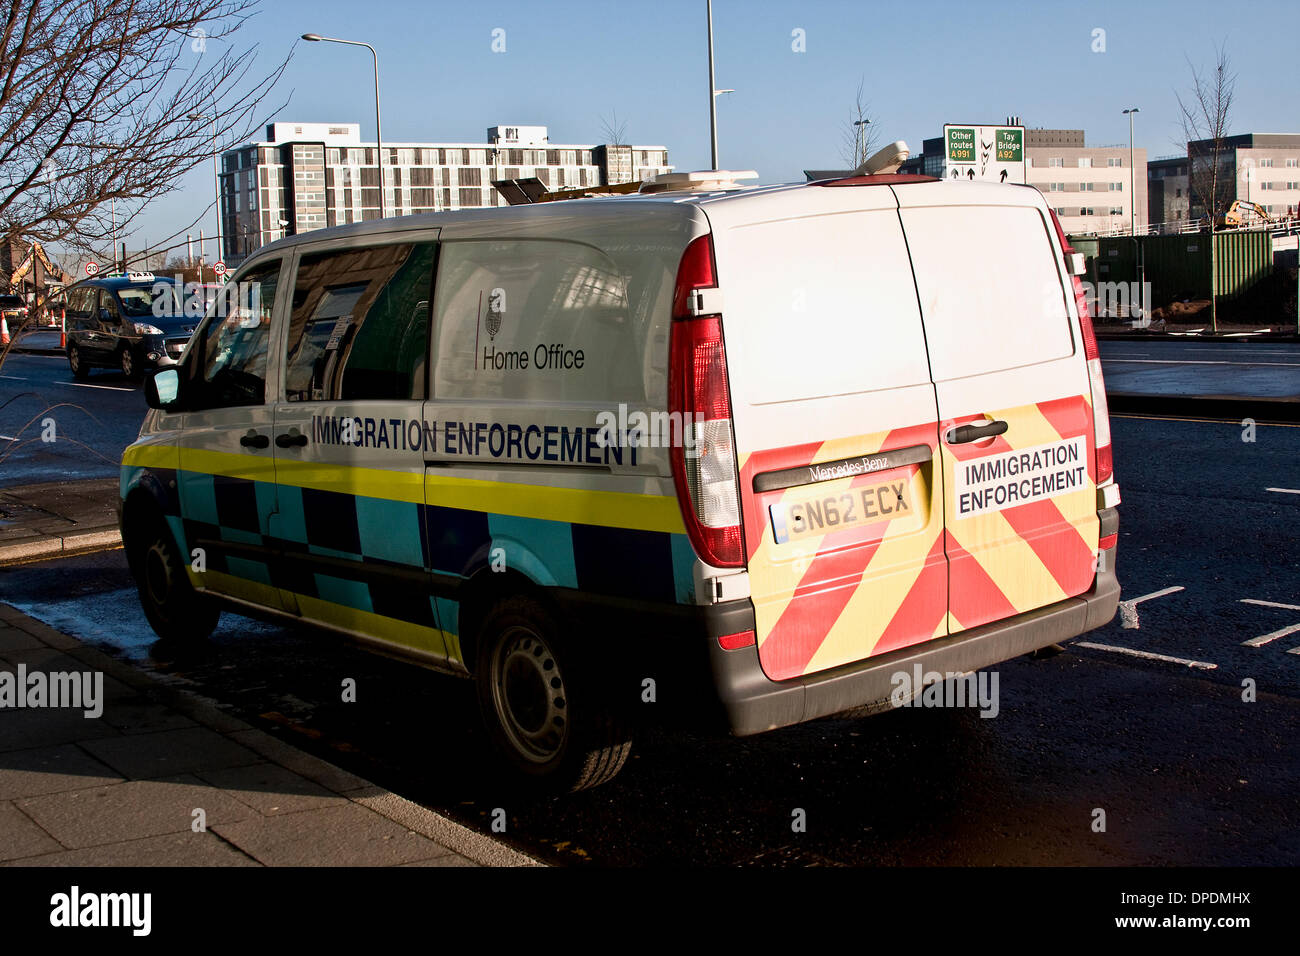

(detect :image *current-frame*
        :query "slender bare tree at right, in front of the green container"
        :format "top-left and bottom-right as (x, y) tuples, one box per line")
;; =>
(1178, 44), (1236, 333)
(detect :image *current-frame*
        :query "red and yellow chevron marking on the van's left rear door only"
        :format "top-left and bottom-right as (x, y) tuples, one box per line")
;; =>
(741, 423), (948, 680)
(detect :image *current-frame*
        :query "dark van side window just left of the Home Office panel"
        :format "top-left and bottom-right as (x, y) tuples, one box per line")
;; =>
(285, 242), (437, 402)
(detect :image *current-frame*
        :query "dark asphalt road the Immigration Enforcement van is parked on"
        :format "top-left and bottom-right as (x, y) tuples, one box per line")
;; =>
(0, 418), (1300, 865)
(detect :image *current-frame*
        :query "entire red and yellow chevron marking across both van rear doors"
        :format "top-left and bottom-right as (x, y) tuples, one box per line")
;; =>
(741, 397), (1099, 680)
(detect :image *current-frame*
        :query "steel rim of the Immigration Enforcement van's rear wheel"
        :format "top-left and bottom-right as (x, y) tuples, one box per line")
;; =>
(491, 626), (568, 763)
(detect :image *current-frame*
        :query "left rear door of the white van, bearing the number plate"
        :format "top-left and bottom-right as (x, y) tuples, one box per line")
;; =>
(703, 187), (948, 680)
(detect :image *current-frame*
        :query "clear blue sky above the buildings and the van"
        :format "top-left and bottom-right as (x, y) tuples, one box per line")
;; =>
(114, 0), (1300, 265)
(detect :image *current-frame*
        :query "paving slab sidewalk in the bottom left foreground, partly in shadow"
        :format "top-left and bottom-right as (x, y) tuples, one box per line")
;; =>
(0, 604), (542, 866)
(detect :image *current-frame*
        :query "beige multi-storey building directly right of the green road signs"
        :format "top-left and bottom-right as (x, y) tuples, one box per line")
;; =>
(1024, 129), (1148, 235)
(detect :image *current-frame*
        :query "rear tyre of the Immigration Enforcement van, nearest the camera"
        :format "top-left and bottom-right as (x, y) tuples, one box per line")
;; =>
(475, 596), (632, 792)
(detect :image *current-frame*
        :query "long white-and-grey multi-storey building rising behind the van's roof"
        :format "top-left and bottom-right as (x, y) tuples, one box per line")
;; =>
(220, 122), (672, 263)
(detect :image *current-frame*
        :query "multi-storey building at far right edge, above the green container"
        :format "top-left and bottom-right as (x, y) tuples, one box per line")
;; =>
(1187, 133), (1300, 219)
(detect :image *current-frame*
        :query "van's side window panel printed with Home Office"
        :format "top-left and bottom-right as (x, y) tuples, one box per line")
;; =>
(433, 239), (645, 402)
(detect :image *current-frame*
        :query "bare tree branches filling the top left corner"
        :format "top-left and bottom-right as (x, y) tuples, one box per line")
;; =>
(0, 0), (291, 360)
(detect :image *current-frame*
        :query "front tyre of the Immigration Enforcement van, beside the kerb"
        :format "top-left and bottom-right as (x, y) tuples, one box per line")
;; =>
(126, 512), (221, 644)
